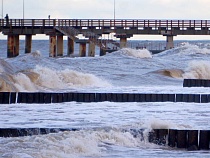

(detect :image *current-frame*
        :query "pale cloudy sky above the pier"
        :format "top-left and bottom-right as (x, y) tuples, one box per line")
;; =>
(0, 0), (210, 39)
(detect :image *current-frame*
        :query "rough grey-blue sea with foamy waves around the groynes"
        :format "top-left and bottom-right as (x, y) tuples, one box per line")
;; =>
(0, 40), (210, 158)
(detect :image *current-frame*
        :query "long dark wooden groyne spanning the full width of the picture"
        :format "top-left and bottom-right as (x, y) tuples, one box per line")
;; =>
(0, 92), (210, 104)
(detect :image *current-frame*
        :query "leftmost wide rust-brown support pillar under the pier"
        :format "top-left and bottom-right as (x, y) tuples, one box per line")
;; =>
(7, 35), (19, 58)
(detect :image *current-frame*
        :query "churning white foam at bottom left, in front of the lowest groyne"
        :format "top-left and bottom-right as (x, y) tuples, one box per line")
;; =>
(0, 130), (144, 158)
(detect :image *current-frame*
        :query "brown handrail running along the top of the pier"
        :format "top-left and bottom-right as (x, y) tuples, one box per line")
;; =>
(0, 19), (210, 29)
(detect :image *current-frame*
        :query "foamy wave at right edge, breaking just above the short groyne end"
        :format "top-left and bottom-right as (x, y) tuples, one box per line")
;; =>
(182, 61), (210, 79)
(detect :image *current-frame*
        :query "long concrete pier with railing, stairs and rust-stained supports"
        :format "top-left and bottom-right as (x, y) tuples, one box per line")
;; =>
(0, 19), (210, 57)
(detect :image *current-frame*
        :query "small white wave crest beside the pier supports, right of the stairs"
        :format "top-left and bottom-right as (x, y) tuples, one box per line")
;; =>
(120, 48), (152, 58)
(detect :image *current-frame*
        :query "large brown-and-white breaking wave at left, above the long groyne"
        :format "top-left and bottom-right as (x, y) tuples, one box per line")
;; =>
(0, 65), (110, 92)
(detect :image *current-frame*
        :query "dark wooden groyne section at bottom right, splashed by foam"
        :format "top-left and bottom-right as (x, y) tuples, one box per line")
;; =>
(149, 129), (210, 150)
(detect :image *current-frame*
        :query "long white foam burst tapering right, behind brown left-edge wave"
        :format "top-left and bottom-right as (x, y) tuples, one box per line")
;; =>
(33, 66), (110, 89)
